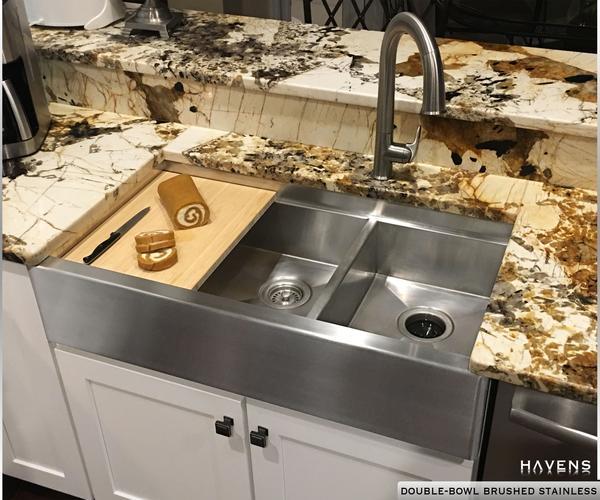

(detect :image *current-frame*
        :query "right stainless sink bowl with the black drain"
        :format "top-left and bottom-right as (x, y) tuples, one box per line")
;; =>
(318, 221), (508, 356)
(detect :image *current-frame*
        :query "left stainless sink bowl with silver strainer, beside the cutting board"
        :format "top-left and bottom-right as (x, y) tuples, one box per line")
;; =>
(200, 202), (366, 316)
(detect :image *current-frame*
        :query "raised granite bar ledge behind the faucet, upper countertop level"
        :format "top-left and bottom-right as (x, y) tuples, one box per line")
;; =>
(33, 7), (597, 137)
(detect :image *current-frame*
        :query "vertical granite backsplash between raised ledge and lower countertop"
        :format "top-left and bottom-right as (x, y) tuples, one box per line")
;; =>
(42, 60), (596, 189)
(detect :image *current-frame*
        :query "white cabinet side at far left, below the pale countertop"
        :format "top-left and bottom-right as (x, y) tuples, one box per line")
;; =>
(2, 262), (91, 498)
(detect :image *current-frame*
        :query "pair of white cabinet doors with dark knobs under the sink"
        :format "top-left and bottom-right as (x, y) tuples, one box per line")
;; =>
(55, 347), (473, 500)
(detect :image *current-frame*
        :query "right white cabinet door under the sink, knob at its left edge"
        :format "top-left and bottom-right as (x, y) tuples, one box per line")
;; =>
(247, 401), (473, 500)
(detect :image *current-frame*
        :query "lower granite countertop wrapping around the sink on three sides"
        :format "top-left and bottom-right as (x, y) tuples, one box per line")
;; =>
(3, 105), (597, 403)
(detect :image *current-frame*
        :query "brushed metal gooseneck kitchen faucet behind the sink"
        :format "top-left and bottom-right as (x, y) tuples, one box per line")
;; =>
(372, 12), (446, 180)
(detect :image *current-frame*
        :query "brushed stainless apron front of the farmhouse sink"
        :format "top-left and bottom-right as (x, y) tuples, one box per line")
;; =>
(31, 258), (489, 460)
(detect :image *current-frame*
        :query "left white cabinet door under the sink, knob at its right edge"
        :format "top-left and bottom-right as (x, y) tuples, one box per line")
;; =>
(56, 350), (252, 500)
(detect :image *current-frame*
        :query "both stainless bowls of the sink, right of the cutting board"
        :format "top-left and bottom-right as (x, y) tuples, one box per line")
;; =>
(199, 187), (511, 356)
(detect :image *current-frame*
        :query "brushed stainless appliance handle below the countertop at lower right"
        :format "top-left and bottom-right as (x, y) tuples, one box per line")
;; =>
(510, 387), (598, 450)
